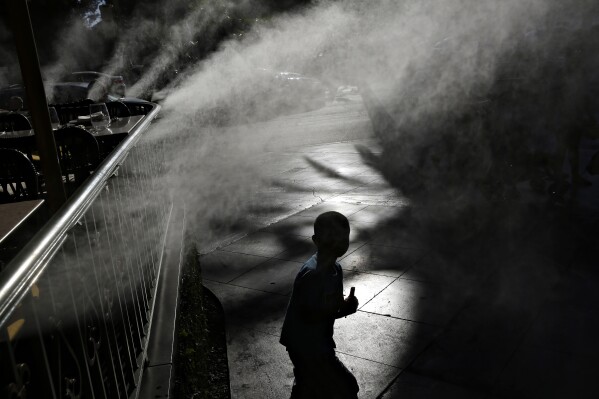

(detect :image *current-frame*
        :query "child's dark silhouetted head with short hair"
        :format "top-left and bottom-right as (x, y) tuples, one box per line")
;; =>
(312, 211), (349, 257)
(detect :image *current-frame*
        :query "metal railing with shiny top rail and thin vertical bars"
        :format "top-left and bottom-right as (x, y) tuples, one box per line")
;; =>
(0, 105), (166, 398)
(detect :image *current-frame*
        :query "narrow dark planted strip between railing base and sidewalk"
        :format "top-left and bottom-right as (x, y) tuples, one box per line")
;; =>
(173, 247), (231, 399)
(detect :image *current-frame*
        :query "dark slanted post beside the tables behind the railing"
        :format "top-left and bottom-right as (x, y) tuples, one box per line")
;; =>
(5, 0), (66, 214)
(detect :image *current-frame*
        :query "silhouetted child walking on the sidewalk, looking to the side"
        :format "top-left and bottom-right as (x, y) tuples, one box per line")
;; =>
(280, 212), (359, 399)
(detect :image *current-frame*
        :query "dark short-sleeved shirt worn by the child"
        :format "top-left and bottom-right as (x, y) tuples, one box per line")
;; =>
(279, 253), (343, 353)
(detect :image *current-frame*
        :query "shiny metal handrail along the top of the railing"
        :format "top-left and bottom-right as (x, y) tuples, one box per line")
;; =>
(0, 104), (161, 326)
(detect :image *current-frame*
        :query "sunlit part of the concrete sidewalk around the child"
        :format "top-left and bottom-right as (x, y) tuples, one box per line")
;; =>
(200, 140), (412, 398)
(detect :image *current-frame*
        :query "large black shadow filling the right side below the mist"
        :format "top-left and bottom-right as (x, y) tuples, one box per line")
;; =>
(354, 28), (599, 398)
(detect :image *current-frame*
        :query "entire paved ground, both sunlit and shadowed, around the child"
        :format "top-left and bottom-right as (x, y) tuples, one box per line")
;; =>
(193, 97), (599, 399)
